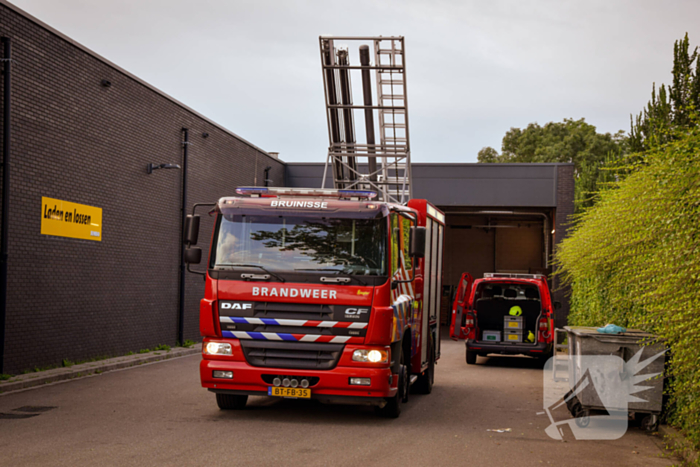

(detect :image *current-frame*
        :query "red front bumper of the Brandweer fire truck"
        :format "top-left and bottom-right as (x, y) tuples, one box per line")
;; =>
(199, 356), (398, 405)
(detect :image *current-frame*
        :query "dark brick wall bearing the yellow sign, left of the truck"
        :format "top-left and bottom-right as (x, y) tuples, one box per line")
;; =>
(0, 4), (284, 373)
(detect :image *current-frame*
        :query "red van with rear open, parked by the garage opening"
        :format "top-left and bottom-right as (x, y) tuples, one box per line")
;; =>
(450, 273), (559, 365)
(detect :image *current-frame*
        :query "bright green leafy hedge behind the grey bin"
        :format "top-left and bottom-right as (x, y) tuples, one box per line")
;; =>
(555, 127), (700, 446)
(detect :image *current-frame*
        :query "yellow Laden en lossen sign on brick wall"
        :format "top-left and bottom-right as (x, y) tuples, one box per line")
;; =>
(41, 196), (102, 242)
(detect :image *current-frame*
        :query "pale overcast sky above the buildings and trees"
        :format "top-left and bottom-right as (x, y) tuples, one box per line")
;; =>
(13, 0), (700, 162)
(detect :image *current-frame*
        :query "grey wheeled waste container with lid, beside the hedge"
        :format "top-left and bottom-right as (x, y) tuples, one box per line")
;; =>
(564, 326), (666, 431)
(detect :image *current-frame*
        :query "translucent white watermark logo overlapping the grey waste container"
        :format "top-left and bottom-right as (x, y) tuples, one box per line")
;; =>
(538, 348), (665, 440)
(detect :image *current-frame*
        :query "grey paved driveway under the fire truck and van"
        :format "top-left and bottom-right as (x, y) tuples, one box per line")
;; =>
(0, 340), (674, 467)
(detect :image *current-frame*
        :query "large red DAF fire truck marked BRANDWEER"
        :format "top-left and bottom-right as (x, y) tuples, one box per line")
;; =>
(185, 187), (444, 417)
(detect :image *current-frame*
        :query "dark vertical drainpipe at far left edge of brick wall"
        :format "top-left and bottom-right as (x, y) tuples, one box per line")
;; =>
(0, 37), (12, 373)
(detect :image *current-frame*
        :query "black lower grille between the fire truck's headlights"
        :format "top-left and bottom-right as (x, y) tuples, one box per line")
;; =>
(240, 339), (345, 370)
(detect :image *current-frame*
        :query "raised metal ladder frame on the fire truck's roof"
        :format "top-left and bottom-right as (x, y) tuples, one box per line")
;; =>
(319, 36), (412, 204)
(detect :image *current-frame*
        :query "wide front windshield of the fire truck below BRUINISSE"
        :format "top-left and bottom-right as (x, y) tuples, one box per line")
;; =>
(214, 215), (387, 276)
